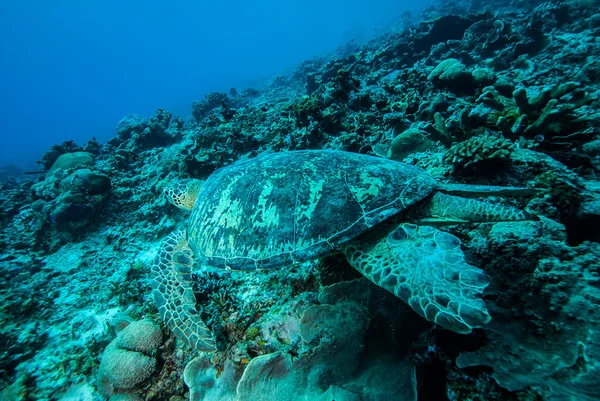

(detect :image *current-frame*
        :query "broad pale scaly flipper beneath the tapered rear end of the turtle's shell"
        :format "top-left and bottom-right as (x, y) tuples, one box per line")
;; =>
(344, 224), (490, 334)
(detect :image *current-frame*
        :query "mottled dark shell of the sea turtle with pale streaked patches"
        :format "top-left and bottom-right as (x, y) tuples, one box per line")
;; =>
(187, 150), (436, 270)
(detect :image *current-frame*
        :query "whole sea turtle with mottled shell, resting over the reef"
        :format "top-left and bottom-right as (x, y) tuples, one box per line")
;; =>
(151, 150), (537, 351)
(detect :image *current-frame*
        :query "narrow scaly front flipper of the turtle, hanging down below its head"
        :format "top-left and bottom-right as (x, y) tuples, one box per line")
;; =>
(150, 231), (216, 352)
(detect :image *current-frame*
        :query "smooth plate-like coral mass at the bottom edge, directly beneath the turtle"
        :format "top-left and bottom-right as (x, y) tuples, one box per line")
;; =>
(184, 278), (424, 401)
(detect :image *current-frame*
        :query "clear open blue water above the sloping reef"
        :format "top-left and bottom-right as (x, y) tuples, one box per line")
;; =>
(0, 0), (427, 167)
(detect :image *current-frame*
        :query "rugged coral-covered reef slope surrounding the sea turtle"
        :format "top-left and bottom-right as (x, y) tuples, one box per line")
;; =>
(0, 0), (600, 401)
